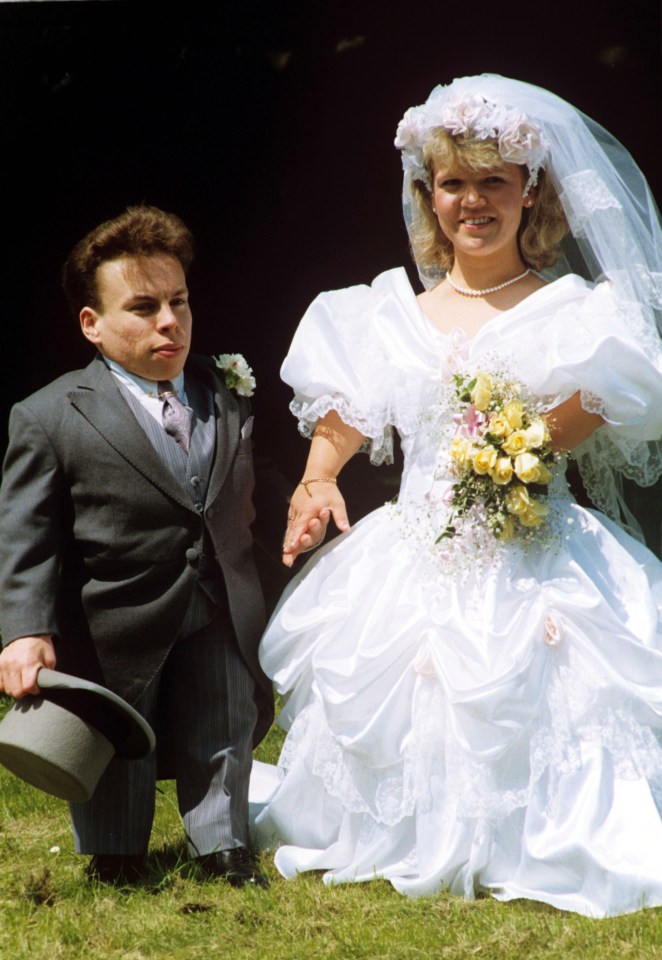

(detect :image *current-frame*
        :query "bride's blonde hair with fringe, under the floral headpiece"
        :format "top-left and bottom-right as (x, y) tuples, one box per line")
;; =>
(409, 127), (569, 271)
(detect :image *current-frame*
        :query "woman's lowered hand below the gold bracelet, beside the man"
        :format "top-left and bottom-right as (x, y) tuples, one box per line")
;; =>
(283, 478), (349, 567)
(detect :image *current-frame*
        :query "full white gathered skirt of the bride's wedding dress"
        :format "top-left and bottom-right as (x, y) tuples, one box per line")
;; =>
(256, 505), (662, 916)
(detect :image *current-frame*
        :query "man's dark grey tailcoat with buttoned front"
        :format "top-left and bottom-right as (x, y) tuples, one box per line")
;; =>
(0, 357), (278, 741)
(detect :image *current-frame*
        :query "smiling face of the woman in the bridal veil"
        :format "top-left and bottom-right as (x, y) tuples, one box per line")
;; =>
(432, 163), (532, 257)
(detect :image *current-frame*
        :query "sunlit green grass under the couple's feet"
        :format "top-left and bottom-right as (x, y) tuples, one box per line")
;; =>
(0, 696), (662, 960)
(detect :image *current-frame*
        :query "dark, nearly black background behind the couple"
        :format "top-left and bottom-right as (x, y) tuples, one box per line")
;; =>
(0, 0), (662, 540)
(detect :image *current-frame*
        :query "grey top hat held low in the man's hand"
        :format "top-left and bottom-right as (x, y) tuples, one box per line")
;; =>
(0, 667), (156, 802)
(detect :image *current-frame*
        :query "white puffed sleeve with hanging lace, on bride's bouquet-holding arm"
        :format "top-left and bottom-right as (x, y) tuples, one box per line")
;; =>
(531, 282), (662, 519)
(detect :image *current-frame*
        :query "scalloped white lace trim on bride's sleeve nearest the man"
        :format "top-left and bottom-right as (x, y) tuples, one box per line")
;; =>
(290, 393), (393, 466)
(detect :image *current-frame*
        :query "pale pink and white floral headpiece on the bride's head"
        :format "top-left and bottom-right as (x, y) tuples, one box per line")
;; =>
(395, 87), (549, 194)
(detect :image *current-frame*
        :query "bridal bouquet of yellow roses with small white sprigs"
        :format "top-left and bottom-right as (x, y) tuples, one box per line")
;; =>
(436, 373), (556, 543)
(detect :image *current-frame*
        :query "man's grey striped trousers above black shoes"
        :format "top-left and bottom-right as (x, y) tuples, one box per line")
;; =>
(70, 610), (257, 857)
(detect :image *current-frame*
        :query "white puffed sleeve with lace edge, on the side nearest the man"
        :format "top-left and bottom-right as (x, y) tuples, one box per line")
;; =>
(281, 285), (393, 464)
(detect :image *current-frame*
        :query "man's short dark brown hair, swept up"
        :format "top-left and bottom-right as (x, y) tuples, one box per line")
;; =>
(62, 206), (193, 318)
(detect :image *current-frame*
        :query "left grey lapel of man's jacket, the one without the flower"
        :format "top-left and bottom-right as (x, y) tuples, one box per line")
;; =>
(68, 357), (193, 510)
